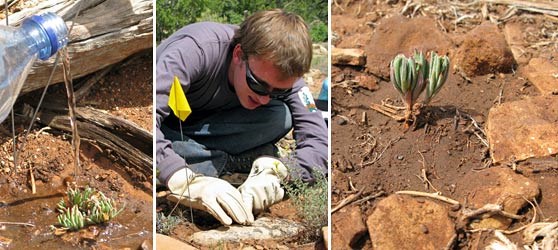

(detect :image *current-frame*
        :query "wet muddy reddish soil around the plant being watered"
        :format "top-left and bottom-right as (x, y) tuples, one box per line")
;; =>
(0, 51), (153, 249)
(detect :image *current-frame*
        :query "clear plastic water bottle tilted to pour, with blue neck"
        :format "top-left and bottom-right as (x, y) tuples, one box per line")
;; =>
(0, 13), (68, 122)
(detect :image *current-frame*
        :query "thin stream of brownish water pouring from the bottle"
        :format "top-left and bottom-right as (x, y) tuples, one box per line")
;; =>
(58, 48), (81, 180)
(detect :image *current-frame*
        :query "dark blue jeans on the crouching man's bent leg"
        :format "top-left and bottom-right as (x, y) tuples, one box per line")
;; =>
(161, 100), (292, 177)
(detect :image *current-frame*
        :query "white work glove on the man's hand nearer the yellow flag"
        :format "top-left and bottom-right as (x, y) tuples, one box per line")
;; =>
(167, 168), (254, 226)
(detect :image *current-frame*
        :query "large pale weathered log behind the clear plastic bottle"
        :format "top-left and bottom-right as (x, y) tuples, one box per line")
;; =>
(0, 0), (153, 94)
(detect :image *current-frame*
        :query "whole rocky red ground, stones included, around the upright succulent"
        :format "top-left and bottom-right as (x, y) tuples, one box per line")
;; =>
(331, 1), (558, 249)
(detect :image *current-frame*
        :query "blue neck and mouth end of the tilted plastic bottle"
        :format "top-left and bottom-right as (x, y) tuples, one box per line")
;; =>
(26, 12), (68, 60)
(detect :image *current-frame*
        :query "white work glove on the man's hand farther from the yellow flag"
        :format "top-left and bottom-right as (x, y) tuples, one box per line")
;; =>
(238, 156), (288, 214)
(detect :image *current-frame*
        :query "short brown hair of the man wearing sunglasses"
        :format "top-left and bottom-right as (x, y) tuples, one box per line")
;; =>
(233, 9), (312, 77)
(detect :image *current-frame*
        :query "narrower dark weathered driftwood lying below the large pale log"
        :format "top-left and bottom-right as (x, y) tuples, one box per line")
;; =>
(32, 106), (153, 181)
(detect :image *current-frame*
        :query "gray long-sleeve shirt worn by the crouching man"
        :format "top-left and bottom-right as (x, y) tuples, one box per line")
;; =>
(155, 22), (327, 183)
